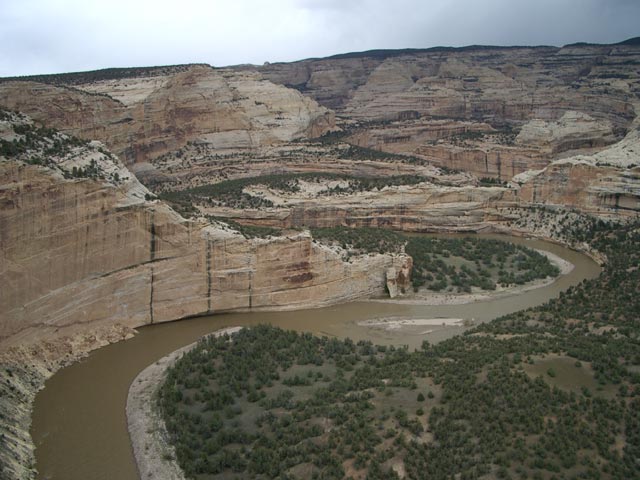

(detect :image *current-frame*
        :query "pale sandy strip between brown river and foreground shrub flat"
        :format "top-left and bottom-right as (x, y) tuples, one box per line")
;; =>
(126, 327), (242, 480)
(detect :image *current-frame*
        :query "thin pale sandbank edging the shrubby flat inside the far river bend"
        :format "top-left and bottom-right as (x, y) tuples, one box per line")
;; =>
(370, 250), (575, 306)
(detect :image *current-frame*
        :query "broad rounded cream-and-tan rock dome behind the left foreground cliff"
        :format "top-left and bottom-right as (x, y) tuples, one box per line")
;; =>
(0, 66), (334, 165)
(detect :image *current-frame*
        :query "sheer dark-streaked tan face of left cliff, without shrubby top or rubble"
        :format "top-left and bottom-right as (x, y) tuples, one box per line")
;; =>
(0, 162), (405, 346)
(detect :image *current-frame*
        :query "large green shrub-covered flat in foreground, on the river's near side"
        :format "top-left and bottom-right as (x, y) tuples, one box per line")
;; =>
(158, 223), (640, 480)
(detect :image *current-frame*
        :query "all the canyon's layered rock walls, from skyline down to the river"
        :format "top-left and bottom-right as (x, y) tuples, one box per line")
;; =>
(0, 39), (640, 478)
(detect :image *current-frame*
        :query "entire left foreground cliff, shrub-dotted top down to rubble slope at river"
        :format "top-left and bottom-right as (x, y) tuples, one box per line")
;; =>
(0, 112), (410, 478)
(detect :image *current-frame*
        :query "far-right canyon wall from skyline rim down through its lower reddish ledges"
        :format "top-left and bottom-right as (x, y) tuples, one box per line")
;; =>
(246, 44), (640, 180)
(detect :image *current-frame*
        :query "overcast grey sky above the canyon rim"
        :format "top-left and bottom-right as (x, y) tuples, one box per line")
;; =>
(0, 0), (640, 77)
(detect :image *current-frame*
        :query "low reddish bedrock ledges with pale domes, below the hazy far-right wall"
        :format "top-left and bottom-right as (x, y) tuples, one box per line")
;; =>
(349, 111), (618, 181)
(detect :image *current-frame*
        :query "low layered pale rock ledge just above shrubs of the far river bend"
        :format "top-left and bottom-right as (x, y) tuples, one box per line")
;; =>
(200, 182), (515, 232)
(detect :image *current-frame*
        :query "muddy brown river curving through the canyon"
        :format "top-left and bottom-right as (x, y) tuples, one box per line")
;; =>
(31, 235), (600, 480)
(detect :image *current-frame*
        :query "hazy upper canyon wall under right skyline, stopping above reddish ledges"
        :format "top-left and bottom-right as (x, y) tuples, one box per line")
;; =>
(256, 44), (640, 127)
